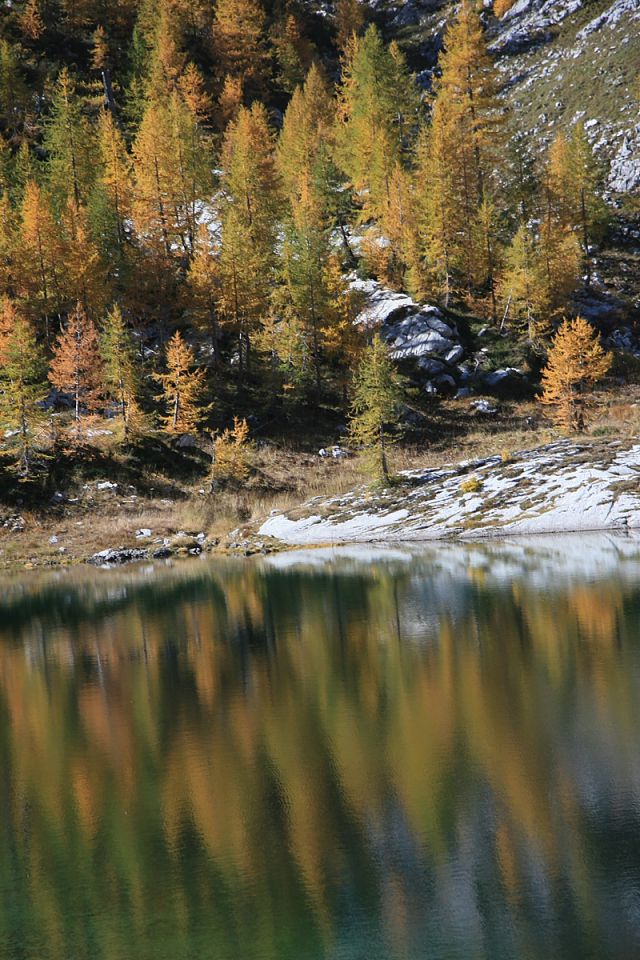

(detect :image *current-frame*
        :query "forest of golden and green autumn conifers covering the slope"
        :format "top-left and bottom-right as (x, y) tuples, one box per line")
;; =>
(0, 0), (632, 506)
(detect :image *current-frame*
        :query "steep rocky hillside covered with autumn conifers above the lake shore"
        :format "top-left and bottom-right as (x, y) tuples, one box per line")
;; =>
(0, 0), (640, 559)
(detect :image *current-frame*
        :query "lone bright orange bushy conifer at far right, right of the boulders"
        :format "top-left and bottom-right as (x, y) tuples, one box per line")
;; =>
(540, 317), (611, 431)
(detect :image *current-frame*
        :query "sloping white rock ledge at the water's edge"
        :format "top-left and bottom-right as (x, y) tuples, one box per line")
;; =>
(259, 440), (640, 545)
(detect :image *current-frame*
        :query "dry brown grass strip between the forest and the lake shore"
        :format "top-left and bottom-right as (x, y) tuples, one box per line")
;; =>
(0, 378), (640, 566)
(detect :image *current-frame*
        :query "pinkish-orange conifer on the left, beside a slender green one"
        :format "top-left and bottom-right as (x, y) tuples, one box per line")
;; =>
(49, 303), (104, 441)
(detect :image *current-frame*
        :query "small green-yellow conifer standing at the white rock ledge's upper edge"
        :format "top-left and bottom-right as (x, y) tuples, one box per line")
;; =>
(349, 335), (401, 482)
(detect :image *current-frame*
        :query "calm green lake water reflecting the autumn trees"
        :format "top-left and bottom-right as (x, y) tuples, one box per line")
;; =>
(0, 536), (640, 960)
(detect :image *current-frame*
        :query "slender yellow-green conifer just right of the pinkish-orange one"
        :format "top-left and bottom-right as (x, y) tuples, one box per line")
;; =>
(100, 306), (142, 441)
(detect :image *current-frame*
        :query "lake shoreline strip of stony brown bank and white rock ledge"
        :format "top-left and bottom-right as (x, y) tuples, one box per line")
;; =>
(0, 438), (640, 570)
